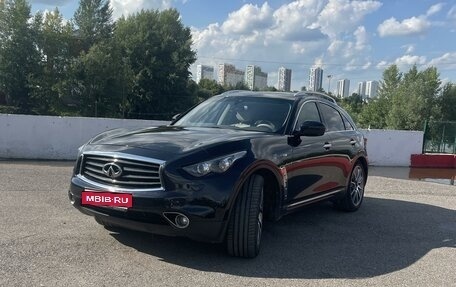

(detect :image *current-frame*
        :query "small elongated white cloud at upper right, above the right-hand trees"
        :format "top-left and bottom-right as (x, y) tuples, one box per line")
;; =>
(377, 16), (431, 37)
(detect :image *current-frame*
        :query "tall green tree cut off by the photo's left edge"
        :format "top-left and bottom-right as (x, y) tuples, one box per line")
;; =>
(0, 0), (39, 112)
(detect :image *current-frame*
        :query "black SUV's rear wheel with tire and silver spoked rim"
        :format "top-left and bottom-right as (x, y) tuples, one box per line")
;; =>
(335, 162), (366, 212)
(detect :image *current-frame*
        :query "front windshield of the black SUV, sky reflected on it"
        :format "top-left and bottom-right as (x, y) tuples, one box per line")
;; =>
(174, 96), (293, 133)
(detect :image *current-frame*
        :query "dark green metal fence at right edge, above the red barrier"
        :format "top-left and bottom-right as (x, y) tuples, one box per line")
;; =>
(423, 121), (456, 154)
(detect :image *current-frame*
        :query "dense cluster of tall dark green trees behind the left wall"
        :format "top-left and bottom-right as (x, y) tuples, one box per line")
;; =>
(0, 0), (200, 119)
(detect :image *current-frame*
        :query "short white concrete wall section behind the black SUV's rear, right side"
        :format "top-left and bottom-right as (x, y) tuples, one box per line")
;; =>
(362, 130), (423, 166)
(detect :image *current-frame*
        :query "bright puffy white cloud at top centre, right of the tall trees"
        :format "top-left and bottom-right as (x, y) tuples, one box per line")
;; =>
(222, 2), (272, 34)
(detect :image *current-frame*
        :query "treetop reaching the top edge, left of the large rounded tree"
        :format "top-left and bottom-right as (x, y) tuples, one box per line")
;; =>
(74, 0), (113, 52)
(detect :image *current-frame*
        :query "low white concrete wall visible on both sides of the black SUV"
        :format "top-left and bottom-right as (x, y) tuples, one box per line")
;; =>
(0, 114), (423, 166)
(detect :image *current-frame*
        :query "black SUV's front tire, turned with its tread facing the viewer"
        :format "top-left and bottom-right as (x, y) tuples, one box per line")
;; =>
(226, 174), (264, 258)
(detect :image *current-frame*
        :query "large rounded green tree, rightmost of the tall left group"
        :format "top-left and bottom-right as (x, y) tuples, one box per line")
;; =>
(114, 9), (196, 119)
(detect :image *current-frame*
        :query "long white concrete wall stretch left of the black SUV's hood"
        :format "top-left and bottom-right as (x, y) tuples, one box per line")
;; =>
(0, 114), (168, 160)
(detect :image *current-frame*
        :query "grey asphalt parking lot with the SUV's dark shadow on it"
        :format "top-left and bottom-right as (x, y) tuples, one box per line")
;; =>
(0, 161), (456, 286)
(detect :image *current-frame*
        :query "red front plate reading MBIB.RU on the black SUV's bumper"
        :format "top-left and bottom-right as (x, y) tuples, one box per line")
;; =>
(82, 190), (133, 208)
